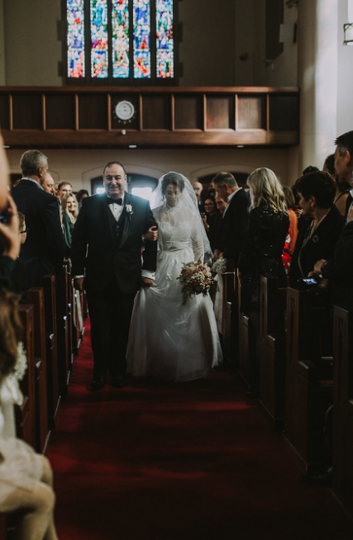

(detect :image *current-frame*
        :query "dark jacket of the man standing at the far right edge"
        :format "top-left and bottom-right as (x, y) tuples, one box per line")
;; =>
(322, 221), (353, 313)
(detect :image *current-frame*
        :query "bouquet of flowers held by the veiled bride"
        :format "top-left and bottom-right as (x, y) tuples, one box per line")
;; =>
(177, 261), (217, 304)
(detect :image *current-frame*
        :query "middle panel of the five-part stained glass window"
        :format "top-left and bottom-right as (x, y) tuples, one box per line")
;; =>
(112, 0), (130, 79)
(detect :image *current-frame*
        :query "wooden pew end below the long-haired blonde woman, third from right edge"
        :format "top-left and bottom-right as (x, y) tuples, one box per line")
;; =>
(259, 276), (287, 430)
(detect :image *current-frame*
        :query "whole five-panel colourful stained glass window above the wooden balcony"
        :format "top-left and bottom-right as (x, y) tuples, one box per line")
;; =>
(62, 0), (175, 83)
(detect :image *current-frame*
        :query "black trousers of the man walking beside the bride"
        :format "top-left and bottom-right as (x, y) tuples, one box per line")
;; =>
(87, 280), (135, 380)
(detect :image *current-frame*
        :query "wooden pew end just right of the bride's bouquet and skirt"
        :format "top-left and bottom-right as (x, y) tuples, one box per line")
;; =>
(222, 260), (239, 369)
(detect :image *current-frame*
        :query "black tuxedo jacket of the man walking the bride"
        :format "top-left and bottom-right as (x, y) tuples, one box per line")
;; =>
(71, 192), (157, 294)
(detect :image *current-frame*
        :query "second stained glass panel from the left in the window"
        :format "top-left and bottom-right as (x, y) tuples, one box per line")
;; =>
(91, 0), (109, 79)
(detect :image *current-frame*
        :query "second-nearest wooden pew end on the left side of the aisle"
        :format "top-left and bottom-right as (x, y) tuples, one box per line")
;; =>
(27, 287), (50, 454)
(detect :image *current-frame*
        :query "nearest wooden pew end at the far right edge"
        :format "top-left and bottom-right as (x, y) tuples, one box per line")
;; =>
(333, 306), (353, 515)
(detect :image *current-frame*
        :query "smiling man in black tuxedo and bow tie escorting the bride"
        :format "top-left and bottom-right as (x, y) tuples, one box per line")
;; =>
(71, 161), (157, 390)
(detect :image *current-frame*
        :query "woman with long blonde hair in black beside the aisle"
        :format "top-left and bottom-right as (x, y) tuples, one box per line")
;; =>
(238, 167), (289, 398)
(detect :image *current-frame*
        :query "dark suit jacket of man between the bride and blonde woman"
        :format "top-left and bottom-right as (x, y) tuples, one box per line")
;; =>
(216, 189), (251, 265)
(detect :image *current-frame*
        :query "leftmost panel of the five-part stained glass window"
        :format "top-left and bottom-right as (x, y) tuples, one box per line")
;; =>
(66, 0), (85, 78)
